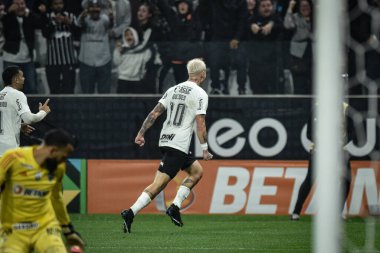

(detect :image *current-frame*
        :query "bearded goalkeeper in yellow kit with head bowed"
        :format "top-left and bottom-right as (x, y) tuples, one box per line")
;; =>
(0, 129), (84, 253)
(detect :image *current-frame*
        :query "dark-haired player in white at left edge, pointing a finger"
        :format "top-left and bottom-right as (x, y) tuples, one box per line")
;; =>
(0, 66), (50, 157)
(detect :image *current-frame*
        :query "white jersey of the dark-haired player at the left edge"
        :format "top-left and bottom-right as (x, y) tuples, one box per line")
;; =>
(0, 86), (30, 156)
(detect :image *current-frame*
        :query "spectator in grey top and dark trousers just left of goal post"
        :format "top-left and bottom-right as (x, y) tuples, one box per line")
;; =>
(284, 0), (313, 94)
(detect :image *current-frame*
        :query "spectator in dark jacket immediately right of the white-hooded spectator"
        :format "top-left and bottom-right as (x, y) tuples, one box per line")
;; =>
(136, 2), (165, 93)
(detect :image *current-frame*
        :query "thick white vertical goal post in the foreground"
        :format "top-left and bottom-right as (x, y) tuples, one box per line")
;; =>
(313, 0), (345, 253)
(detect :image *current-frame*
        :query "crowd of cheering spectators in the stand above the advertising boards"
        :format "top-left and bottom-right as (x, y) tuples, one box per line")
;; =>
(0, 0), (380, 95)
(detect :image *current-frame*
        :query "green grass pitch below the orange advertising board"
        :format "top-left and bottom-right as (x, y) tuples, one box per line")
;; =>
(71, 214), (380, 253)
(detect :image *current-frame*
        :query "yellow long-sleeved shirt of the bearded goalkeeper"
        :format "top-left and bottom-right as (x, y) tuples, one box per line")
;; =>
(0, 146), (70, 229)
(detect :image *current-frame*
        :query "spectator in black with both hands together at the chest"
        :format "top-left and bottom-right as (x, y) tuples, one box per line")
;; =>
(248, 0), (283, 94)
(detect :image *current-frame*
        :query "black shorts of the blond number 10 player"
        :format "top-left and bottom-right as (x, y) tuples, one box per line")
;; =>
(158, 147), (195, 179)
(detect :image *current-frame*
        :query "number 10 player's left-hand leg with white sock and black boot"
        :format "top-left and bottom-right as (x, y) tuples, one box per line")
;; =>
(121, 171), (170, 233)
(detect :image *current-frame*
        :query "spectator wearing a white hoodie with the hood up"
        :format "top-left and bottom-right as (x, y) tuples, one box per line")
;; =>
(113, 27), (152, 93)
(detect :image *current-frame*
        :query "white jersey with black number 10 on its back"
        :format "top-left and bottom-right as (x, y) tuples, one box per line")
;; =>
(158, 81), (208, 154)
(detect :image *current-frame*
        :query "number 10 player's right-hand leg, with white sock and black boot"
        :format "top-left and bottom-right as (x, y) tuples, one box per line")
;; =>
(166, 161), (203, 227)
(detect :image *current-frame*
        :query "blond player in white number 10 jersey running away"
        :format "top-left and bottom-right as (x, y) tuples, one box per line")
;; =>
(121, 59), (212, 233)
